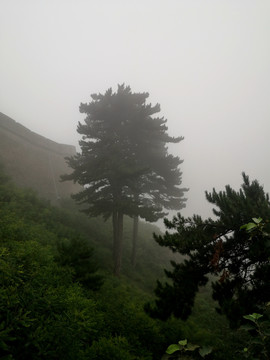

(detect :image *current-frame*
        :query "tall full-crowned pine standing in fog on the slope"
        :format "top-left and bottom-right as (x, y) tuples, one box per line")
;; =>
(62, 85), (187, 275)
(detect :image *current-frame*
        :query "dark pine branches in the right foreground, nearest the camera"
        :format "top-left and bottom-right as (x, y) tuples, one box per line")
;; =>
(146, 173), (270, 327)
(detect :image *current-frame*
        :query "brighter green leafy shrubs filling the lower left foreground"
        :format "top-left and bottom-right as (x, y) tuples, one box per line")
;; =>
(0, 211), (102, 359)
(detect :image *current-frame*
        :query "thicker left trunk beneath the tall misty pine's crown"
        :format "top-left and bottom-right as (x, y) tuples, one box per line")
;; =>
(113, 211), (123, 276)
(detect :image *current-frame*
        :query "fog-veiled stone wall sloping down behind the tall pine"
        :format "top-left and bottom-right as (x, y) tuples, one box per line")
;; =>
(0, 113), (79, 203)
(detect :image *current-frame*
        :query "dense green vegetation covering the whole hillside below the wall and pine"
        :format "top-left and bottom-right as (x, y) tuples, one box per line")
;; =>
(0, 167), (268, 360)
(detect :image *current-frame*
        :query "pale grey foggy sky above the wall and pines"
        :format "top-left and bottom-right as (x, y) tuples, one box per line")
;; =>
(0, 0), (270, 216)
